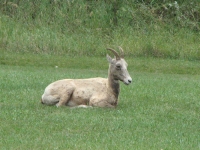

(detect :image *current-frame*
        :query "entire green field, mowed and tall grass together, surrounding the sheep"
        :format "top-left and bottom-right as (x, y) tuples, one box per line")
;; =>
(0, 0), (200, 150)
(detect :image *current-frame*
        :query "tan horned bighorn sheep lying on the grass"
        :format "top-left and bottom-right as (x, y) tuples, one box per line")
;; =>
(41, 47), (132, 108)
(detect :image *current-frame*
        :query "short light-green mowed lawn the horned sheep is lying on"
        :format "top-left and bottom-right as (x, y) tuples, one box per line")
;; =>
(0, 59), (200, 150)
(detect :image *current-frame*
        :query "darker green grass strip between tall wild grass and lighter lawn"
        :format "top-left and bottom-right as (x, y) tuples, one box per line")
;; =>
(0, 49), (200, 75)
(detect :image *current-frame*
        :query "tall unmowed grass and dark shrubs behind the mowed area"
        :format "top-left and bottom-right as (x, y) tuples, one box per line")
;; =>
(0, 0), (200, 60)
